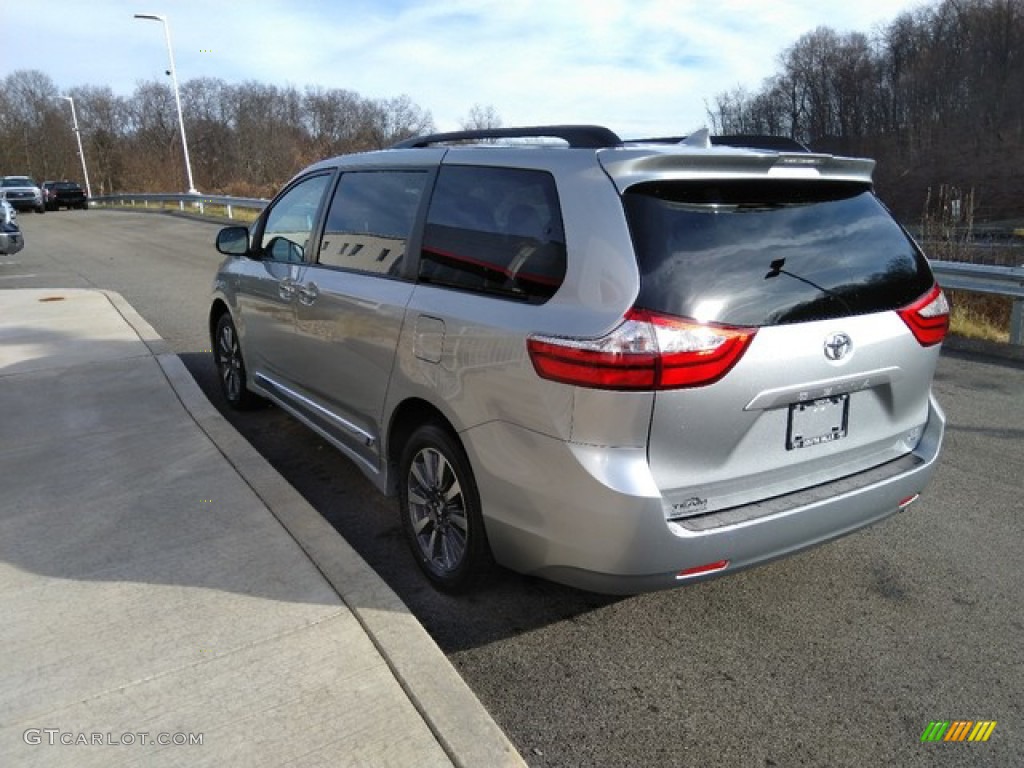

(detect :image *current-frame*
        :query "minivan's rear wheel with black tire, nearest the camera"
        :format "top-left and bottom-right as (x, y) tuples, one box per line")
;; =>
(398, 424), (493, 592)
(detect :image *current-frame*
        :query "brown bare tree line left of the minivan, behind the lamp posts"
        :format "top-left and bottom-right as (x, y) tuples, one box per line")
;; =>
(0, 70), (500, 197)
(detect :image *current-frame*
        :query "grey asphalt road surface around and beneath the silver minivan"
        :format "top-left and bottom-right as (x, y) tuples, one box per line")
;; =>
(0, 211), (1024, 768)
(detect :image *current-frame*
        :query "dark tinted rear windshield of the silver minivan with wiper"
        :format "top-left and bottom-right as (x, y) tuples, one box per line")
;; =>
(624, 181), (934, 326)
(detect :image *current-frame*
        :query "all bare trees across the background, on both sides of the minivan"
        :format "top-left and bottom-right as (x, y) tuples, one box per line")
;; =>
(0, 0), (1024, 221)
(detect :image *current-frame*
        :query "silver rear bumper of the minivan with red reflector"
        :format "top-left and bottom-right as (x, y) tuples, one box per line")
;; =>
(464, 397), (945, 594)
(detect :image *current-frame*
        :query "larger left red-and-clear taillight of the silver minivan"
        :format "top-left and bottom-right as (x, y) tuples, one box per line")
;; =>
(526, 309), (757, 390)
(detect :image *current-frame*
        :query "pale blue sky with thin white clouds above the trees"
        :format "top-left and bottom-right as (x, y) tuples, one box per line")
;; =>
(0, 0), (938, 138)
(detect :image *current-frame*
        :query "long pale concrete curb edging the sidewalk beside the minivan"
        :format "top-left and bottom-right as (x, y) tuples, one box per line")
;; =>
(100, 291), (526, 768)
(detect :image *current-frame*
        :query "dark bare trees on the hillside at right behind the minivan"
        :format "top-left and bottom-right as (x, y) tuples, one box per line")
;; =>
(708, 0), (1024, 220)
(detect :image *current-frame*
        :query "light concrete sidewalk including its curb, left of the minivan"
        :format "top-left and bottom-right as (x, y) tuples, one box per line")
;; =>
(0, 290), (524, 768)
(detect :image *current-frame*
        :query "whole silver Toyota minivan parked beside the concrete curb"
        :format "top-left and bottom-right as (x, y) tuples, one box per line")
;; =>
(209, 126), (949, 593)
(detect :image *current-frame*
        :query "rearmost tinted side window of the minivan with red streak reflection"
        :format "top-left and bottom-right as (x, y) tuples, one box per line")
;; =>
(419, 166), (565, 303)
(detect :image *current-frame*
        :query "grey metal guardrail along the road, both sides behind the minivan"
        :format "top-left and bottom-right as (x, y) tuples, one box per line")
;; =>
(92, 194), (1024, 344)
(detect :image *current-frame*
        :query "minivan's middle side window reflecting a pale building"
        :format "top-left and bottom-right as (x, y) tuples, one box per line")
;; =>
(317, 171), (428, 275)
